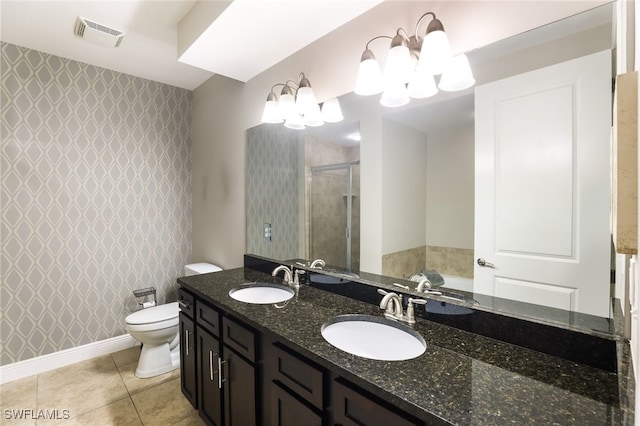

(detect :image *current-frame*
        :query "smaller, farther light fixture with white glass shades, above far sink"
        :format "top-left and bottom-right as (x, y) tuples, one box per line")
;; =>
(262, 73), (344, 129)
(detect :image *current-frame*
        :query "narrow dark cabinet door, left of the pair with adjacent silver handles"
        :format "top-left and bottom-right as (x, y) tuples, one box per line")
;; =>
(197, 327), (223, 426)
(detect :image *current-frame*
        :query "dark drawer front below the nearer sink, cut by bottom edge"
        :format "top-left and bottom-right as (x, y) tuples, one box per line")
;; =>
(331, 381), (423, 426)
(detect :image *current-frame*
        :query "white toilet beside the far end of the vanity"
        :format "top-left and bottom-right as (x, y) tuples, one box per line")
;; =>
(125, 263), (222, 379)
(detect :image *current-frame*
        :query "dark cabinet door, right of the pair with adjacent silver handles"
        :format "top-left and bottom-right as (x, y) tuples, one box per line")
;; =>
(222, 346), (256, 426)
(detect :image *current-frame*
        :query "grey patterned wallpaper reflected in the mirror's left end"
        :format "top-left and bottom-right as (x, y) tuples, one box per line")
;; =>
(246, 124), (303, 260)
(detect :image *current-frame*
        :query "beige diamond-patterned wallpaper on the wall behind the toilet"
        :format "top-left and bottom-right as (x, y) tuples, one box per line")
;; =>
(0, 43), (191, 365)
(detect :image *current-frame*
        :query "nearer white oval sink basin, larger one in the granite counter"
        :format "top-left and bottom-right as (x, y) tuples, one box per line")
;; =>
(321, 315), (427, 361)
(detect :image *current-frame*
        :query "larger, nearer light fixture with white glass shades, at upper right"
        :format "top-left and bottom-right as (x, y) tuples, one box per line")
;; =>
(354, 12), (475, 107)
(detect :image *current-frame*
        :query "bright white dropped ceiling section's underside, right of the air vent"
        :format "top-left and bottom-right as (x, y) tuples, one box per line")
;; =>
(180, 0), (382, 82)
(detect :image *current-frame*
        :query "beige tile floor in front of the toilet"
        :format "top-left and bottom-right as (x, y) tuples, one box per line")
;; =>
(0, 347), (204, 426)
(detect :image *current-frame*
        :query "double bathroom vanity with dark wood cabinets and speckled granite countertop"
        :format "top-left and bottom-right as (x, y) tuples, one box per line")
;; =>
(178, 268), (634, 425)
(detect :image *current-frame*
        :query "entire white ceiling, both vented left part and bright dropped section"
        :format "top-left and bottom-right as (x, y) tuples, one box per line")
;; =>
(0, 0), (382, 90)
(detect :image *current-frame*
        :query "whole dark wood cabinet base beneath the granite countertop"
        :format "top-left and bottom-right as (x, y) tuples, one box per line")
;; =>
(180, 289), (424, 426)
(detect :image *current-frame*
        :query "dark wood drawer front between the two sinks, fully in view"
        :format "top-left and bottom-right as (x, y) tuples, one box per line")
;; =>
(266, 343), (324, 410)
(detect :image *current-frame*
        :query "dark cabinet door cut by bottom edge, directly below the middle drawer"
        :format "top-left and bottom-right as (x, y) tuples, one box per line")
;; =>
(267, 382), (322, 426)
